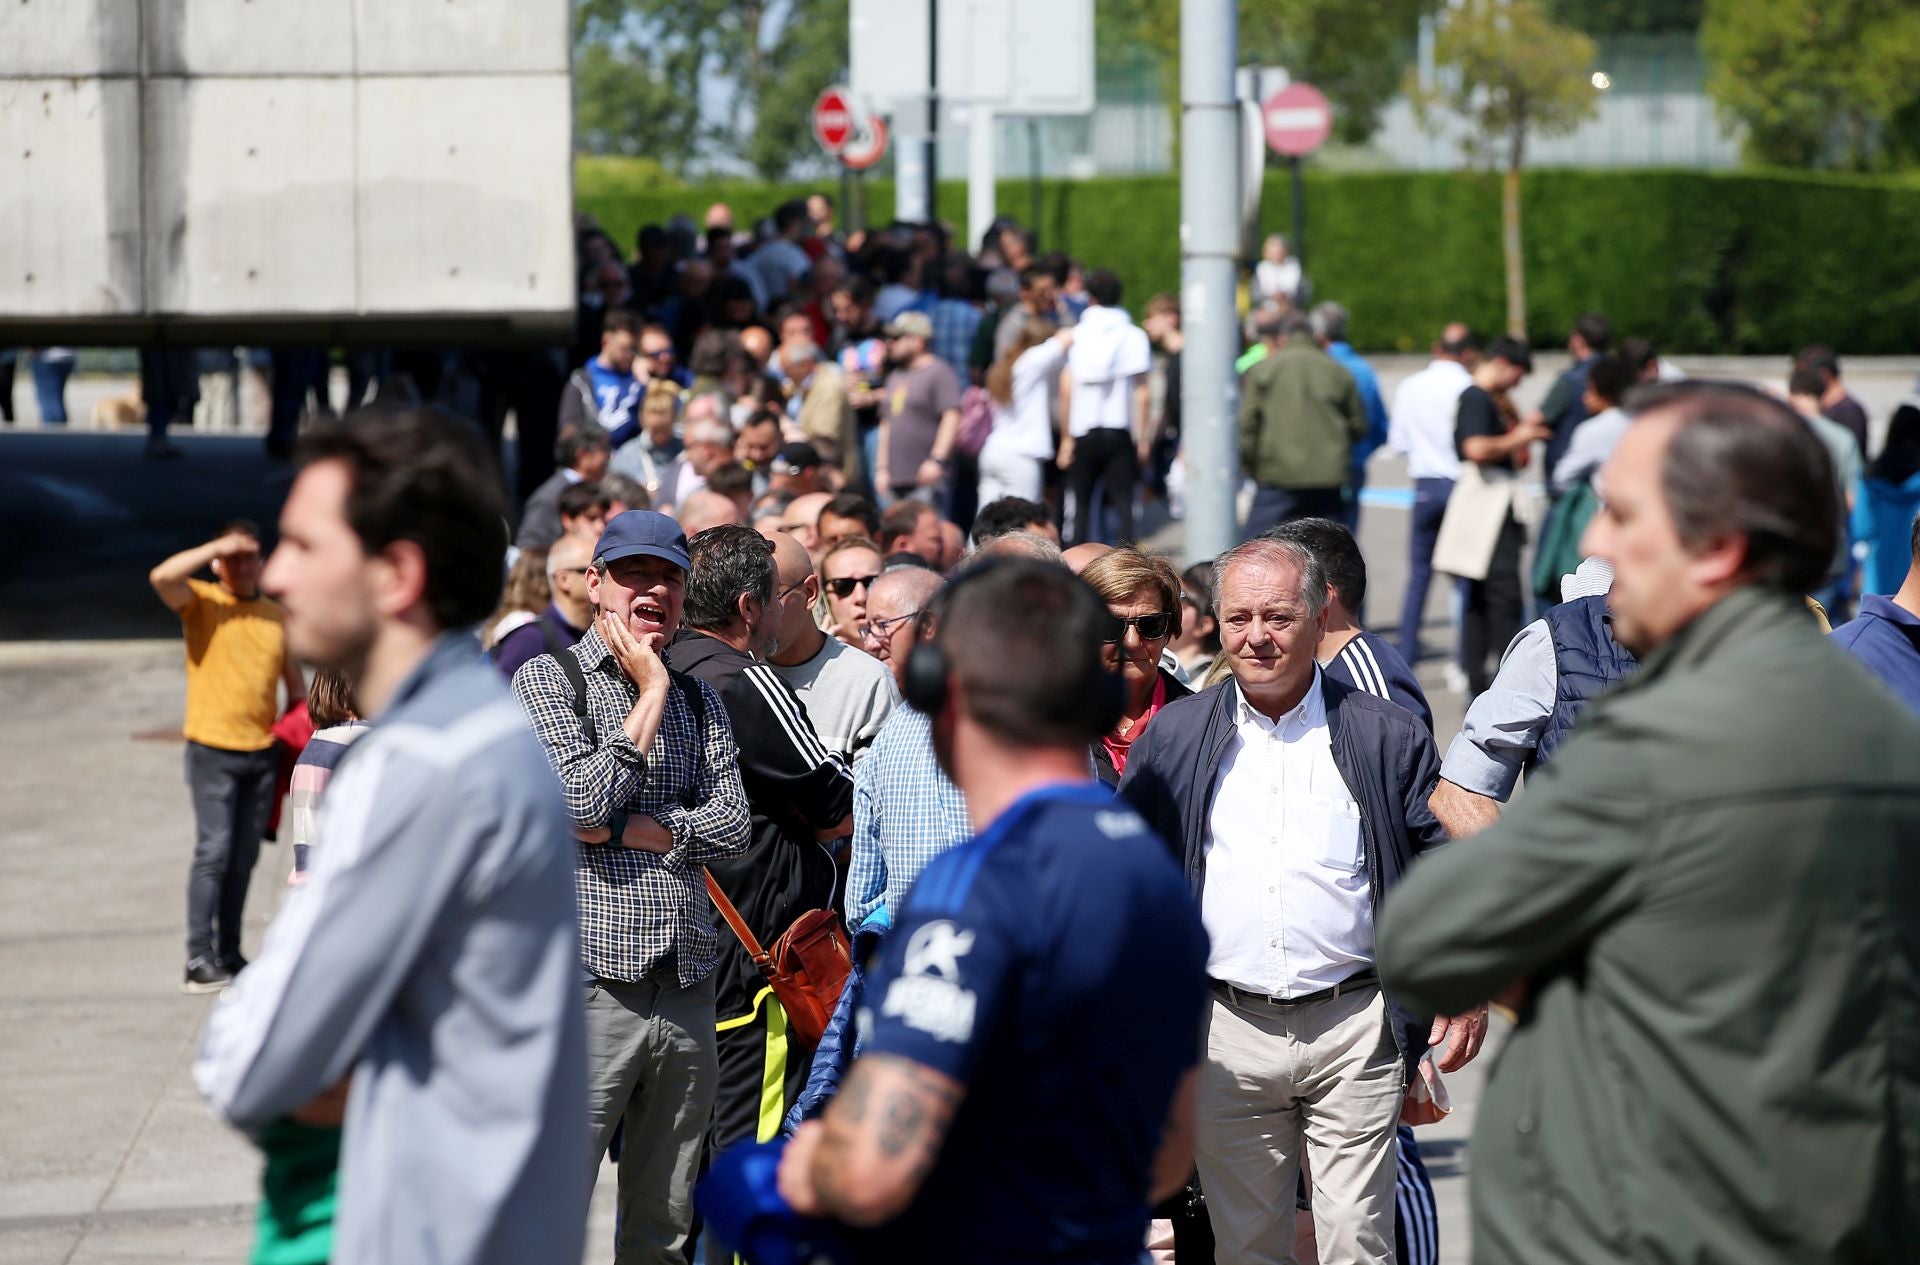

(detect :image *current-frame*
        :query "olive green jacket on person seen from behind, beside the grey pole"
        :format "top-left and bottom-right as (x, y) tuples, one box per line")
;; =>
(1240, 334), (1367, 488)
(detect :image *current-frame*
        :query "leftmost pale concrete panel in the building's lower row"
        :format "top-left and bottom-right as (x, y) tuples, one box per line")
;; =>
(0, 79), (144, 317)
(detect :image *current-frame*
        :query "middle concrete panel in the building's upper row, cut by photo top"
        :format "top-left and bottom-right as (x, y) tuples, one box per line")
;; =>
(144, 0), (353, 75)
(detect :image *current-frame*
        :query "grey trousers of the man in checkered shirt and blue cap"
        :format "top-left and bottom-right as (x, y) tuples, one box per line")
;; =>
(588, 975), (720, 1265)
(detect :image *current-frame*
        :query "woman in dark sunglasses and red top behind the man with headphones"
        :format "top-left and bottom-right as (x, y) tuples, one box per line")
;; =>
(1081, 549), (1192, 785)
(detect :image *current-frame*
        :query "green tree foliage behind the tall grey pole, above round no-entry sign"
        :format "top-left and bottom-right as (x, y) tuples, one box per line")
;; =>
(1105, 0), (1434, 144)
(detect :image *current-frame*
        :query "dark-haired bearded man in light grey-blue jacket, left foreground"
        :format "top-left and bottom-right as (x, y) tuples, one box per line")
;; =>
(194, 413), (591, 1265)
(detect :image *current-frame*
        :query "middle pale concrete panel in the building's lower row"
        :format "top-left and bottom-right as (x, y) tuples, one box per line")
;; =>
(146, 79), (357, 315)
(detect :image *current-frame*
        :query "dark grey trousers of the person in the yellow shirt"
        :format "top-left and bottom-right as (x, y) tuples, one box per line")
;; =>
(186, 743), (280, 966)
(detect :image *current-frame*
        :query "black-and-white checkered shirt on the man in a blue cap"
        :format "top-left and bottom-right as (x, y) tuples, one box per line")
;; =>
(513, 628), (749, 985)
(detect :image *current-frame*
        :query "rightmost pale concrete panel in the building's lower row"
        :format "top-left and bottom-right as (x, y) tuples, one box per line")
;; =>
(359, 75), (574, 315)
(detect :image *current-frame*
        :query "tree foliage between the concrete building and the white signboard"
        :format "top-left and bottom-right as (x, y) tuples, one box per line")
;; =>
(574, 0), (847, 180)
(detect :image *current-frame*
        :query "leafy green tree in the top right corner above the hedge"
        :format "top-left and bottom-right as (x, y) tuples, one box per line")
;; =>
(1699, 0), (1920, 171)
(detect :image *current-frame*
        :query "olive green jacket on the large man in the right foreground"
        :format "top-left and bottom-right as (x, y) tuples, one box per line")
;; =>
(1377, 589), (1920, 1265)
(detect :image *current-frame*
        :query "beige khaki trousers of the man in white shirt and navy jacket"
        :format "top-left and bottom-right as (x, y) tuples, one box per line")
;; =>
(1196, 985), (1405, 1265)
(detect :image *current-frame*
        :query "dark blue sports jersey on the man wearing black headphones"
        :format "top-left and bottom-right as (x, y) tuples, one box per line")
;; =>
(852, 783), (1208, 1265)
